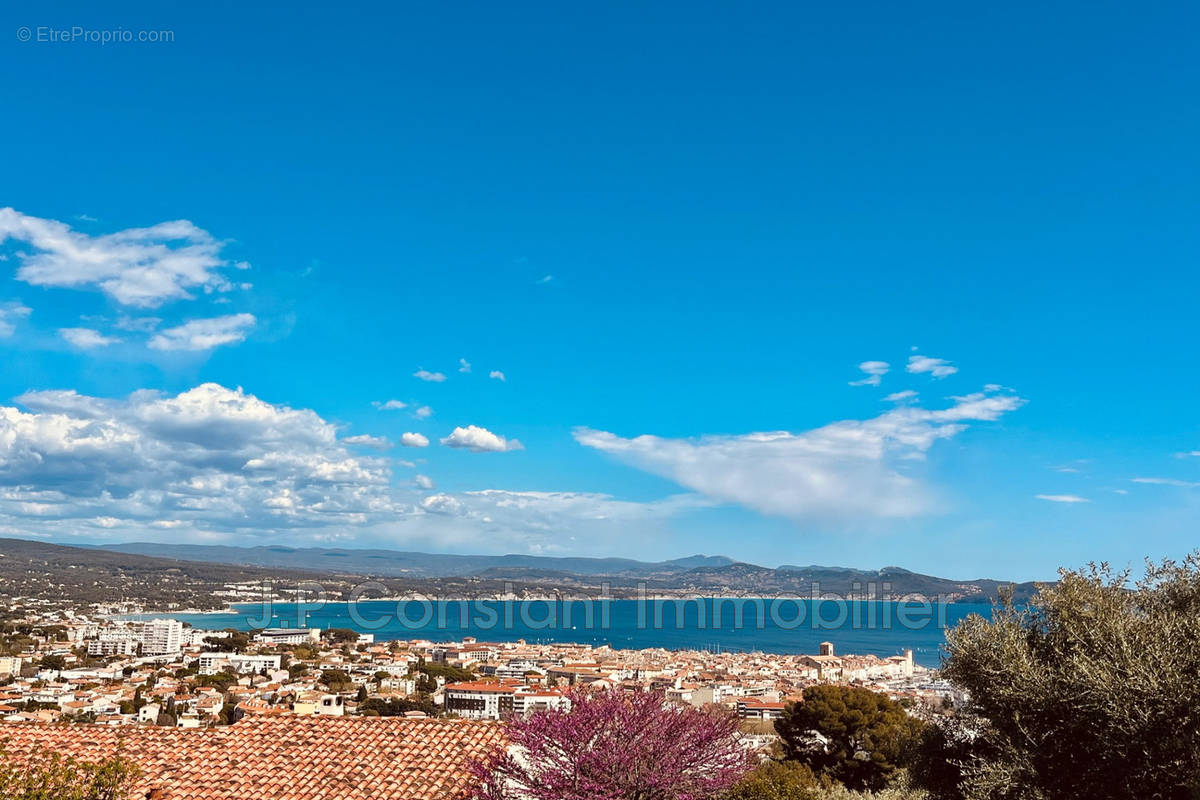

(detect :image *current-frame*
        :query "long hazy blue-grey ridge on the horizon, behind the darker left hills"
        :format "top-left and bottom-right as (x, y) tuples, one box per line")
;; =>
(88, 542), (733, 578)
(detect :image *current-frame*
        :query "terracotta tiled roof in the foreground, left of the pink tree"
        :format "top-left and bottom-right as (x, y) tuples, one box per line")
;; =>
(0, 716), (504, 800)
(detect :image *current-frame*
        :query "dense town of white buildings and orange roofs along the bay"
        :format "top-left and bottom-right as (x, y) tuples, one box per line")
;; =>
(0, 612), (954, 732)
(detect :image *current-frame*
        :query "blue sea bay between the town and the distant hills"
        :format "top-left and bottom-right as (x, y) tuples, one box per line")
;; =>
(143, 597), (991, 667)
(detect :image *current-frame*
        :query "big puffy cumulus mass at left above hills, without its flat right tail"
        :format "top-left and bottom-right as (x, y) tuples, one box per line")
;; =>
(0, 384), (397, 533)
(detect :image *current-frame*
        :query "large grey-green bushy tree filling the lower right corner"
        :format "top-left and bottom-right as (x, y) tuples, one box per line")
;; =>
(943, 554), (1200, 800)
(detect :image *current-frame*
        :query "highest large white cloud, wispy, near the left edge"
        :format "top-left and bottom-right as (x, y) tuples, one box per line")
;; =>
(0, 209), (243, 307)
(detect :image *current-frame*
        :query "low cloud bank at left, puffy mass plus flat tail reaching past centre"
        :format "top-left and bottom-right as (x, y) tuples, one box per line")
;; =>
(0, 384), (710, 552)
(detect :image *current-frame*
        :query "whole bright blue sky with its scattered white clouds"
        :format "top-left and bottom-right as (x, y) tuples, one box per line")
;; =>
(0, 2), (1200, 578)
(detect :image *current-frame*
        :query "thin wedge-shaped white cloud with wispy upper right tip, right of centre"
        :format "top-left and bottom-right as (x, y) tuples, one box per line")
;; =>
(575, 392), (1024, 521)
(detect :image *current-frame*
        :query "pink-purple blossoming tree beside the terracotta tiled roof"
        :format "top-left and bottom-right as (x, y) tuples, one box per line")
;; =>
(473, 690), (751, 800)
